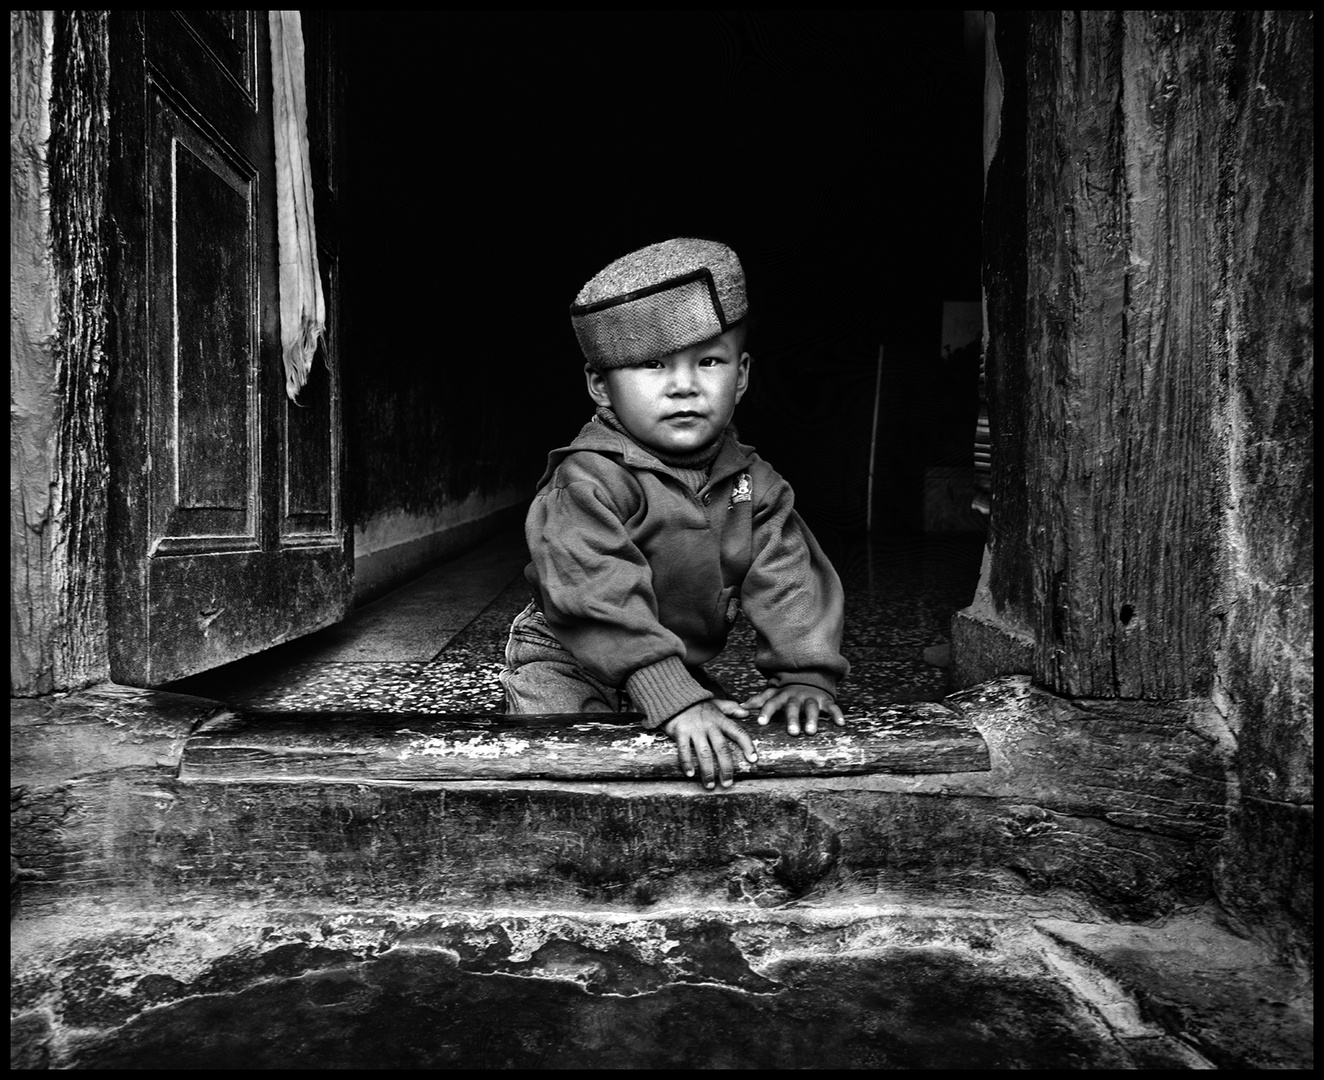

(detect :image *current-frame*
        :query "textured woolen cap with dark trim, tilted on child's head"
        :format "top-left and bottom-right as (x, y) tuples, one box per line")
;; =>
(571, 237), (749, 369)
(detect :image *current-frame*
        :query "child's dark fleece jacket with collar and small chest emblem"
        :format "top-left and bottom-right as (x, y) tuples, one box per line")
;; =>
(524, 422), (850, 728)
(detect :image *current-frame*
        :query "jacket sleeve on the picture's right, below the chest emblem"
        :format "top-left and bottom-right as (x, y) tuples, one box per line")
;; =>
(740, 463), (850, 698)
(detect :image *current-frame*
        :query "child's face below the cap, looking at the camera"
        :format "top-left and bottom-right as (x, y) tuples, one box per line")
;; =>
(585, 328), (749, 455)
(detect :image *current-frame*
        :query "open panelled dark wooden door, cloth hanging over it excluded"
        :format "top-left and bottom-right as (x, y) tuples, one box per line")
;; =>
(107, 11), (352, 686)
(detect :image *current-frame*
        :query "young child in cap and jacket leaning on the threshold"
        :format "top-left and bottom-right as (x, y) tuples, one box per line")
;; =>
(500, 238), (849, 789)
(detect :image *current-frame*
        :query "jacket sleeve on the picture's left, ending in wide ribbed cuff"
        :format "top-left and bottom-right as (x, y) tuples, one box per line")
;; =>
(524, 462), (712, 728)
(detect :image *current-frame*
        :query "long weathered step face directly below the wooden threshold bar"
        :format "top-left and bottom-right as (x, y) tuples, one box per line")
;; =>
(131, 777), (1209, 919)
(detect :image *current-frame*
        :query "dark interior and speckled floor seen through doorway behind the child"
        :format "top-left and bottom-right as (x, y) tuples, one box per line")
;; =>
(173, 11), (982, 711)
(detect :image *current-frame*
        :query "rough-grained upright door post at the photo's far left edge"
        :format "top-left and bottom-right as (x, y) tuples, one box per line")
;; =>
(11, 11), (110, 695)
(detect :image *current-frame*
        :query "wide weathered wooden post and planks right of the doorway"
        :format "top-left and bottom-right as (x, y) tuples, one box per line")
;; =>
(985, 12), (1313, 704)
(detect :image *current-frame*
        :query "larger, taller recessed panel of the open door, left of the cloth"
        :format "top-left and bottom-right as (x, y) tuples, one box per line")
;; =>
(147, 86), (261, 556)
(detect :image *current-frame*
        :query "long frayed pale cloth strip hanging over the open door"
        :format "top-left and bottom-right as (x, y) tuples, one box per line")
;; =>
(269, 11), (326, 404)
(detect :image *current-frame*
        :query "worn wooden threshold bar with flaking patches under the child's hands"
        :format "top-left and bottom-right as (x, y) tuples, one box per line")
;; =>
(180, 703), (988, 781)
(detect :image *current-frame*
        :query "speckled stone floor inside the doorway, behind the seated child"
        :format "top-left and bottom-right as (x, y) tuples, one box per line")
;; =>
(167, 531), (982, 716)
